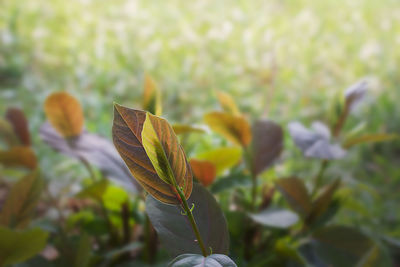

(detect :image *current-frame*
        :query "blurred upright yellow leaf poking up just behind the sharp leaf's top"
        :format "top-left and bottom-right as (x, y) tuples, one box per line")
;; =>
(143, 74), (162, 116)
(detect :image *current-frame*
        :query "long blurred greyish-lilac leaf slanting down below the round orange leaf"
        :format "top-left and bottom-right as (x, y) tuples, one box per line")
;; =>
(40, 123), (141, 192)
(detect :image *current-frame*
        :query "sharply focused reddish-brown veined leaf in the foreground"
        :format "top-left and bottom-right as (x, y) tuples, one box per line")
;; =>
(112, 104), (192, 204)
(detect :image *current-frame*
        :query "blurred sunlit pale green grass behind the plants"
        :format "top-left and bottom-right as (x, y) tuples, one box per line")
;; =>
(0, 0), (400, 237)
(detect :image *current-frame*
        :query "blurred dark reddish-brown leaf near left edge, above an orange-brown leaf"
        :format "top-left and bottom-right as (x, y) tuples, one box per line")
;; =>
(6, 108), (31, 146)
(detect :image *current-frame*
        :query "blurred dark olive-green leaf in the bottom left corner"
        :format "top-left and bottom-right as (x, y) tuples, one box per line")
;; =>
(0, 226), (48, 266)
